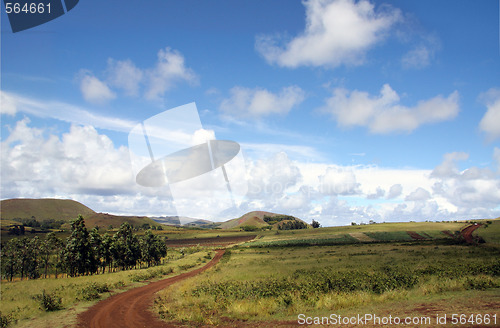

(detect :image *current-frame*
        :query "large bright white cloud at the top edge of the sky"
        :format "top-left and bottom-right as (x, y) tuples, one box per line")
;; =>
(256, 0), (400, 68)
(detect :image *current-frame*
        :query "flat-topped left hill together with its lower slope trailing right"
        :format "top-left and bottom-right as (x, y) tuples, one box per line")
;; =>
(0, 198), (161, 228)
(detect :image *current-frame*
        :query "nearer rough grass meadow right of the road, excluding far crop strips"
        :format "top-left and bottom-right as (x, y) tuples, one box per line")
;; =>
(152, 241), (500, 325)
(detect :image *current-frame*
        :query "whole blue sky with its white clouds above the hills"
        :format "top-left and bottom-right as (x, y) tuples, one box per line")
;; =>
(1, 0), (500, 226)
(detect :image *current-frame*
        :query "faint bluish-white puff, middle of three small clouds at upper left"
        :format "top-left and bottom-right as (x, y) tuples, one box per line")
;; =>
(106, 58), (144, 96)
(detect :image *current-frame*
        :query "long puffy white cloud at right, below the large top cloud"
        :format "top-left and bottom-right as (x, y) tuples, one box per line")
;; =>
(322, 84), (459, 134)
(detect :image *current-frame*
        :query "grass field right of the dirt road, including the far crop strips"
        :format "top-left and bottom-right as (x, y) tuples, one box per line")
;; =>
(156, 221), (500, 326)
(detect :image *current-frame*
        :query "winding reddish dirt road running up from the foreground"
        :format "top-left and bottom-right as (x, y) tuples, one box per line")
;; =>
(77, 250), (224, 328)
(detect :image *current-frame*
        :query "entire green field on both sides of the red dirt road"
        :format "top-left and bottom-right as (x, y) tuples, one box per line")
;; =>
(1, 220), (500, 328)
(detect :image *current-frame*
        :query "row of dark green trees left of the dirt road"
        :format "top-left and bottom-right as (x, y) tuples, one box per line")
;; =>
(1, 215), (167, 281)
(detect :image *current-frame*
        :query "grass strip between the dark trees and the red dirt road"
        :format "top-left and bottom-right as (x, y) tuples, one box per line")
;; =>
(1, 247), (214, 328)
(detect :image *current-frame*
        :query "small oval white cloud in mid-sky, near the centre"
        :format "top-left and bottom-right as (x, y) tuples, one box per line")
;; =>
(220, 86), (305, 118)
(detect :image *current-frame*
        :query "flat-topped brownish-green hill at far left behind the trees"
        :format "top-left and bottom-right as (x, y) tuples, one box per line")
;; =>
(0, 198), (95, 221)
